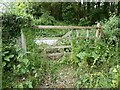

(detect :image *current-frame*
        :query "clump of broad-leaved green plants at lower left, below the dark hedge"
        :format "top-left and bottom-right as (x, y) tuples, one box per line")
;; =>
(2, 44), (30, 88)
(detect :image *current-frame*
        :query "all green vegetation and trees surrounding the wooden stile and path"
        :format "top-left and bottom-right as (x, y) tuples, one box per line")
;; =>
(1, 2), (120, 88)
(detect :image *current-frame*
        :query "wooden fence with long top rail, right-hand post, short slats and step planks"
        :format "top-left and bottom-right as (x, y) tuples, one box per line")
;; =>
(33, 23), (102, 59)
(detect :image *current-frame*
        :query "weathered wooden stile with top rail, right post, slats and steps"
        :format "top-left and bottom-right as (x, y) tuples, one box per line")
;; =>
(33, 23), (102, 59)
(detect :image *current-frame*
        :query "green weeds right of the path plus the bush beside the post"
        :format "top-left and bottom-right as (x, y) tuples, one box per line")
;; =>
(71, 16), (120, 88)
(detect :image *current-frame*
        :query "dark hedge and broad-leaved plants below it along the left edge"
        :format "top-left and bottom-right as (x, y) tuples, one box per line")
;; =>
(2, 13), (34, 87)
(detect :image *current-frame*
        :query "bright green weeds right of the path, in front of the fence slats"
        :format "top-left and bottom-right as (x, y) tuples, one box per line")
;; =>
(72, 40), (120, 88)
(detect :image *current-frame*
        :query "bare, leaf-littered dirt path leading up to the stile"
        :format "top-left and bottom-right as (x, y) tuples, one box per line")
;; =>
(38, 60), (77, 88)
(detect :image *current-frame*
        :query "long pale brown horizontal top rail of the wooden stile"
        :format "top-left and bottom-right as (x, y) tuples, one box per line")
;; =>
(33, 25), (97, 29)
